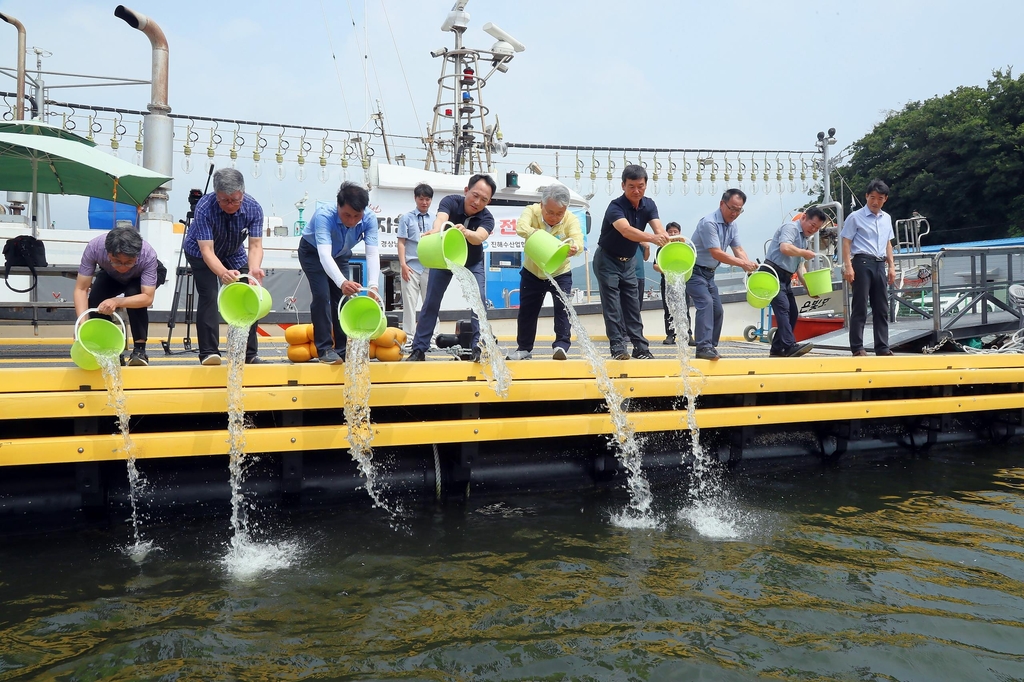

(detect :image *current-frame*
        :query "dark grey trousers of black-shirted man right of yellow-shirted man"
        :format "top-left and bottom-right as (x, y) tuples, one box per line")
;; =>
(594, 247), (649, 355)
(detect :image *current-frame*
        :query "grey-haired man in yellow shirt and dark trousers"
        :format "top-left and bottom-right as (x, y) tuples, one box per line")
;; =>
(508, 183), (583, 359)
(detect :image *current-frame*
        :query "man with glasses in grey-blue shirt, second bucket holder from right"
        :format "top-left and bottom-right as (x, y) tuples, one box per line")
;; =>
(686, 189), (758, 360)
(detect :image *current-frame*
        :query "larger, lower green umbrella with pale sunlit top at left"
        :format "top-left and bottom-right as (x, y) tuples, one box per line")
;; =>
(0, 126), (171, 206)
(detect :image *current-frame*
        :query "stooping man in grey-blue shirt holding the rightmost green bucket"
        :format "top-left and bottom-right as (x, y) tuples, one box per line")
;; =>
(765, 207), (828, 357)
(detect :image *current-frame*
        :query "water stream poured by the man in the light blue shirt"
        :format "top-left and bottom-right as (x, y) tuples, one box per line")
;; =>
(344, 336), (401, 518)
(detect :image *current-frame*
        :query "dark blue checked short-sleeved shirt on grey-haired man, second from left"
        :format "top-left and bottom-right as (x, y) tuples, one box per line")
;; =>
(183, 191), (263, 270)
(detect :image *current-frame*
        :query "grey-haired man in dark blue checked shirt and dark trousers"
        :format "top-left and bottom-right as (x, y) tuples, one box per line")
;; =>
(183, 168), (264, 365)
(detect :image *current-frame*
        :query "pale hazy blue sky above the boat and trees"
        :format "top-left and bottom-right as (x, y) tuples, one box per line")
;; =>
(0, 0), (1024, 249)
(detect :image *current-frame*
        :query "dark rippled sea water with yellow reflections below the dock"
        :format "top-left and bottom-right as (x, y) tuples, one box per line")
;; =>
(0, 445), (1024, 681)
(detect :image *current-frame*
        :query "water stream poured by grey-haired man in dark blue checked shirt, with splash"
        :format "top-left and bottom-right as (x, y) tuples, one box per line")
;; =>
(223, 325), (296, 580)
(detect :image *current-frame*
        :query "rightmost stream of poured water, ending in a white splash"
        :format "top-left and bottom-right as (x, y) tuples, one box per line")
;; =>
(665, 278), (742, 539)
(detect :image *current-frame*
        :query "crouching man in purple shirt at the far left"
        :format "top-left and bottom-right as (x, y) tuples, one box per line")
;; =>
(75, 225), (167, 367)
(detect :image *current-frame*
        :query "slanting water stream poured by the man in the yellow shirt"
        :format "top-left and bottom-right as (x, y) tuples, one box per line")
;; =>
(548, 274), (658, 528)
